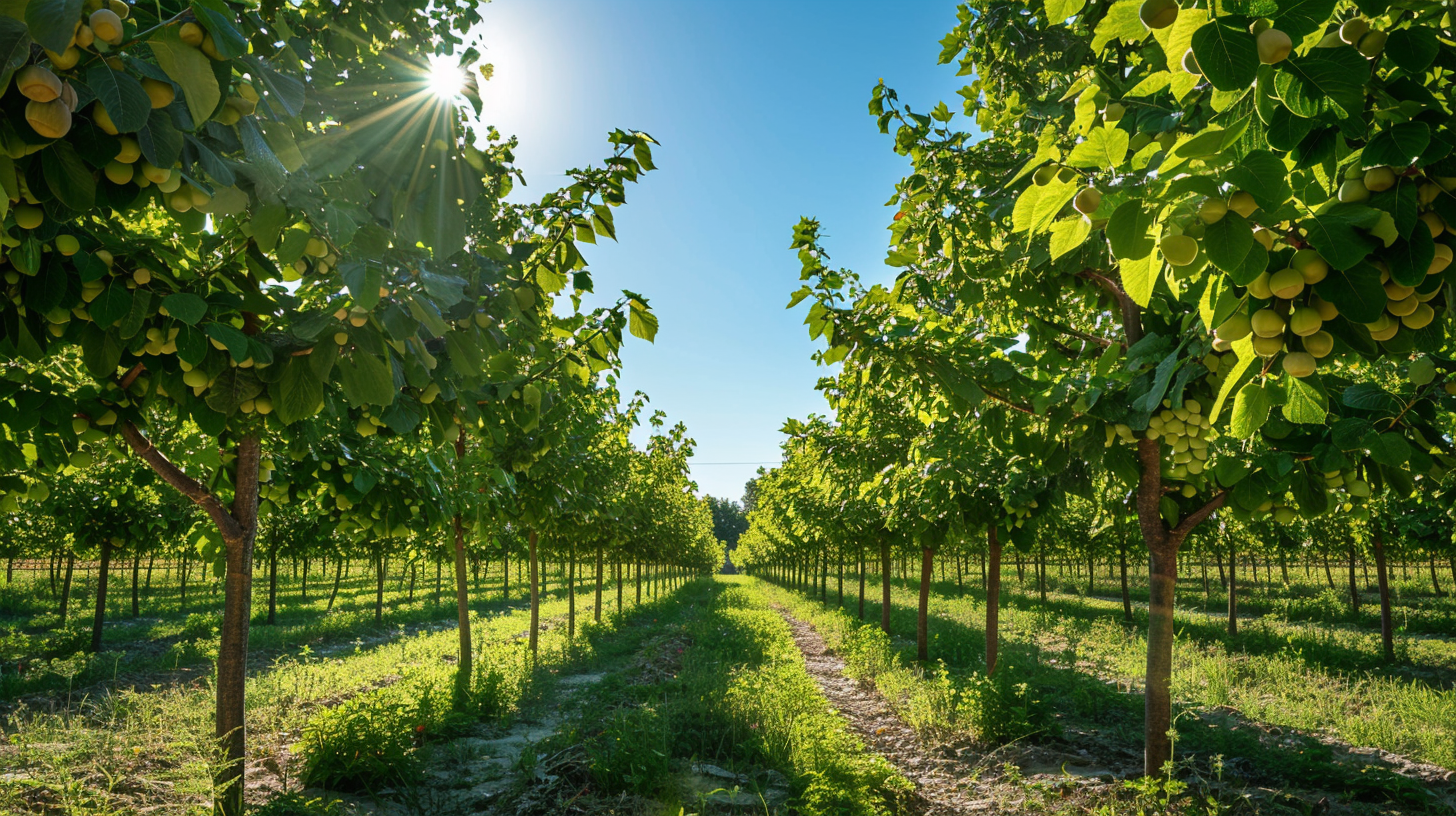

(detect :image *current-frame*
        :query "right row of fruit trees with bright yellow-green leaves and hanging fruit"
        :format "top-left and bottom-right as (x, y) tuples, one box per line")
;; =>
(740, 0), (1456, 775)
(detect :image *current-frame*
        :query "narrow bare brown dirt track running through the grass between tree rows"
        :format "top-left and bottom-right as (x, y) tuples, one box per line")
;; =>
(776, 608), (996, 816)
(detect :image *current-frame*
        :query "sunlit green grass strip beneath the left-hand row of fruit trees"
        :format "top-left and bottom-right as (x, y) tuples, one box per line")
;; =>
(0, 568), (675, 815)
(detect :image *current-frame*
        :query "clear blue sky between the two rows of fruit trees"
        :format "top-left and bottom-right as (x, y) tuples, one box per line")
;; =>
(468, 0), (964, 498)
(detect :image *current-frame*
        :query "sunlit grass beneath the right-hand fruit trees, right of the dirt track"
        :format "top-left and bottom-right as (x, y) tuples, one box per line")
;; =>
(764, 571), (1456, 806)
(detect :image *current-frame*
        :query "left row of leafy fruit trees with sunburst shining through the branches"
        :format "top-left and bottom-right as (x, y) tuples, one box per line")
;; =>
(0, 0), (712, 816)
